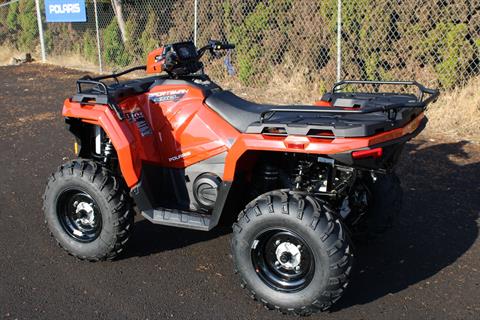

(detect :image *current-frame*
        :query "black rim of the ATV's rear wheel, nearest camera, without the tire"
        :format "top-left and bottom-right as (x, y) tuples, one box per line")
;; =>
(251, 229), (315, 292)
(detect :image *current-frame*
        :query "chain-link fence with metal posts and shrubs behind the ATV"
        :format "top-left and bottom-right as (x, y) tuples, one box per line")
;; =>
(0, 0), (480, 92)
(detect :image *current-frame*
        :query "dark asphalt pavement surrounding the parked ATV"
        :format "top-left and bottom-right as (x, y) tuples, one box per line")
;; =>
(0, 64), (480, 320)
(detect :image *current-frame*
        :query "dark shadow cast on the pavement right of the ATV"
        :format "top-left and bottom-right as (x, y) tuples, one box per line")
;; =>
(332, 141), (480, 311)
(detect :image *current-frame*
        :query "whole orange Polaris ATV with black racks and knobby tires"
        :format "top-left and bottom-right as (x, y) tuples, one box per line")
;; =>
(44, 41), (438, 315)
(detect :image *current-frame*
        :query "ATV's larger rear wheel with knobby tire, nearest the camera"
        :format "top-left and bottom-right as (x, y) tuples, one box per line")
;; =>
(232, 190), (353, 315)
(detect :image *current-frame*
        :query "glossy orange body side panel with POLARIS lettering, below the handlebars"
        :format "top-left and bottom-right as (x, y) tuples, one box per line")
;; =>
(137, 84), (239, 168)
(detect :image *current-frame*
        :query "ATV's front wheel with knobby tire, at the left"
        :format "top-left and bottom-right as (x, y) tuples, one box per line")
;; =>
(43, 160), (133, 261)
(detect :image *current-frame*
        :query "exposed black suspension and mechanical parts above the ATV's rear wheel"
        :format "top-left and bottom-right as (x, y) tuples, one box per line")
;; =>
(253, 153), (368, 224)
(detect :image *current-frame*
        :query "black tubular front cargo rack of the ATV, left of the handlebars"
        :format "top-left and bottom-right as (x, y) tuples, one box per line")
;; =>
(73, 66), (146, 120)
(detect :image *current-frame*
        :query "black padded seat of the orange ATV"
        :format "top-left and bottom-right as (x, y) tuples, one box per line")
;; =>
(205, 90), (295, 132)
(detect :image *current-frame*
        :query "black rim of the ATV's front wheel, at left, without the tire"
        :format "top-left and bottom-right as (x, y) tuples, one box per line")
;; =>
(57, 189), (102, 242)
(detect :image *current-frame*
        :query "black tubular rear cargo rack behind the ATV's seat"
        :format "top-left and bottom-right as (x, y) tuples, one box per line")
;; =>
(260, 80), (440, 124)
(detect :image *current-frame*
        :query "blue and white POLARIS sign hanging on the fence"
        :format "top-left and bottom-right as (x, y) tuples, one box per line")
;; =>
(45, 0), (87, 22)
